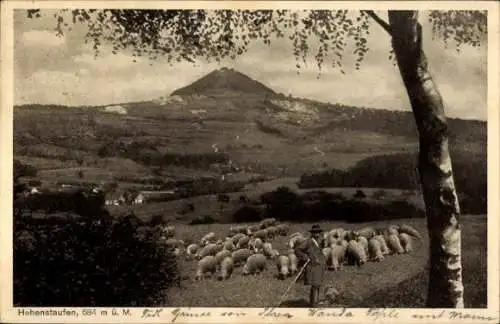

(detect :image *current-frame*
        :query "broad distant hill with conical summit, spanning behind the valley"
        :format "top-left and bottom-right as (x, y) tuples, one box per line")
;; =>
(14, 68), (487, 185)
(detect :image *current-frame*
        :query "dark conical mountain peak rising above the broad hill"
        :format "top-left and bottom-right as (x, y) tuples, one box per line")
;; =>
(172, 67), (276, 96)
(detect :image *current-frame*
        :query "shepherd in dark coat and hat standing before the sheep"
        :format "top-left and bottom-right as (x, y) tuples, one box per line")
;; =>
(295, 224), (326, 307)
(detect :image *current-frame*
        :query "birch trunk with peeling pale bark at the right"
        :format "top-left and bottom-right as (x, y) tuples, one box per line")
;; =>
(389, 11), (464, 308)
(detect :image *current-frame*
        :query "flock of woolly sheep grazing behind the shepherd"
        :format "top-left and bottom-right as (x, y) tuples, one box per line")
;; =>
(156, 218), (421, 280)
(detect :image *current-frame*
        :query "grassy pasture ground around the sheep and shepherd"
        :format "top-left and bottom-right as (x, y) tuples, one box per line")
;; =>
(167, 215), (487, 308)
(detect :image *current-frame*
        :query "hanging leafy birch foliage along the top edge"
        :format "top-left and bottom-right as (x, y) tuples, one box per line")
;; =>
(28, 9), (486, 73)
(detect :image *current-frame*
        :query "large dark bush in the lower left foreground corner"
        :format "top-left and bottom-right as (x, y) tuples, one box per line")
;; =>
(13, 216), (179, 307)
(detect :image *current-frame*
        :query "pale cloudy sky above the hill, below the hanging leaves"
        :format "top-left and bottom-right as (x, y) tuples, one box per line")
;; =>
(14, 10), (487, 120)
